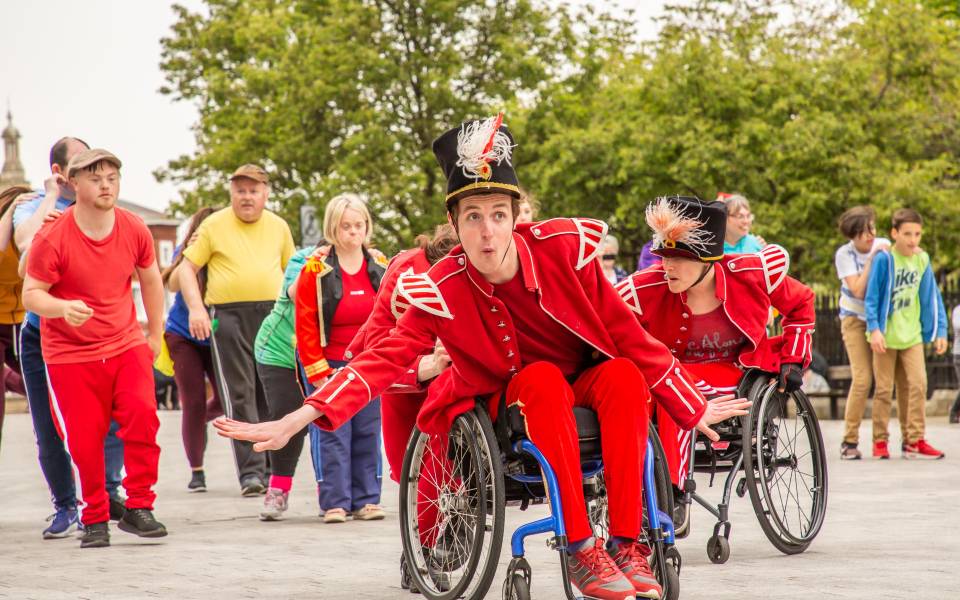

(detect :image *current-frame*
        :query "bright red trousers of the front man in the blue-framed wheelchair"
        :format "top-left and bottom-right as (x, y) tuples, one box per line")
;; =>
(506, 358), (650, 542)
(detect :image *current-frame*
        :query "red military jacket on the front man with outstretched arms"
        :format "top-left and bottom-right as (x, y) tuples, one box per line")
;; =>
(306, 219), (706, 433)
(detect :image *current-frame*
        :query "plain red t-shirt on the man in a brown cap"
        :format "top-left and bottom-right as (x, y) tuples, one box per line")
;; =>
(27, 207), (154, 364)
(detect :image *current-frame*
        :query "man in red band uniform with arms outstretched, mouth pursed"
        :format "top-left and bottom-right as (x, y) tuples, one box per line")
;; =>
(216, 116), (747, 600)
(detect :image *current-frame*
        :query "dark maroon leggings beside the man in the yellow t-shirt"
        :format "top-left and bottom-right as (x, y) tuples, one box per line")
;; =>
(163, 331), (223, 469)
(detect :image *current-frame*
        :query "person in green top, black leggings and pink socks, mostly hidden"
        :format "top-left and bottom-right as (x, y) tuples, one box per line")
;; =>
(253, 247), (315, 521)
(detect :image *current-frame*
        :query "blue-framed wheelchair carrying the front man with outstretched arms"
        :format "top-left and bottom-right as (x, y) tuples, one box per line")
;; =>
(400, 400), (681, 600)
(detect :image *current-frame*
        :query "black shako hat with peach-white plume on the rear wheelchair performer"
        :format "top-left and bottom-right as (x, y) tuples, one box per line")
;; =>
(646, 196), (727, 262)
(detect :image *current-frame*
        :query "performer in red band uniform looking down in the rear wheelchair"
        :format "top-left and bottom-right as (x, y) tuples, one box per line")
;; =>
(617, 196), (814, 534)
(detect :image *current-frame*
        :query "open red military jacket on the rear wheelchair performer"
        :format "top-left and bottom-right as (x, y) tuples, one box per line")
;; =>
(616, 244), (815, 373)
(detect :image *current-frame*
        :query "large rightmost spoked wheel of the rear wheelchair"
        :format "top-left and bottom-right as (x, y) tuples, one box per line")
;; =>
(743, 383), (827, 554)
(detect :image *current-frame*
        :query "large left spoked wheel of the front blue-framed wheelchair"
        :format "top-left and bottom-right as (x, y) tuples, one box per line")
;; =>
(400, 407), (505, 600)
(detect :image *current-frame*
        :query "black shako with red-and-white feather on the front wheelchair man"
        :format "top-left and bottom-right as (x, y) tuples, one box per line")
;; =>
(433, 113), (520, 209)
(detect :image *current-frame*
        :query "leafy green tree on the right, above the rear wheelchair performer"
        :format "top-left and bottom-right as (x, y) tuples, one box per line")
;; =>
(520, 0), (960, 286)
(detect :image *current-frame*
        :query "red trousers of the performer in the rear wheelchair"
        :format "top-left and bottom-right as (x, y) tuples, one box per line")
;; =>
(657, 363), (743, 490)
